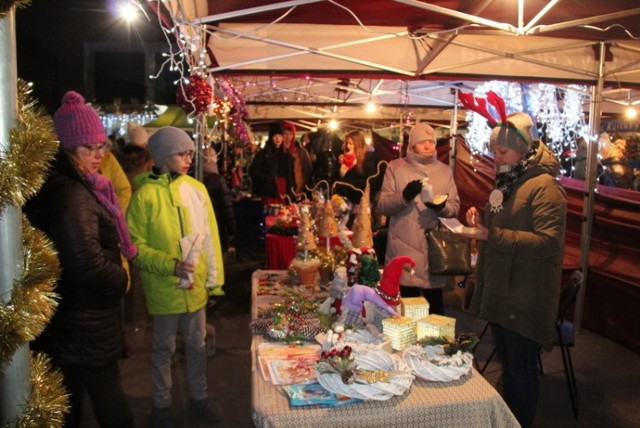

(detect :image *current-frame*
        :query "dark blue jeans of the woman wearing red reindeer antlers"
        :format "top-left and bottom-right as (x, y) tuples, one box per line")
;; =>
(491, 323), (540, 428)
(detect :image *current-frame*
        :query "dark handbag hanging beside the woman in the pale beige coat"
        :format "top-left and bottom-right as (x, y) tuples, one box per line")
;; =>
(425, 229), (471, 275)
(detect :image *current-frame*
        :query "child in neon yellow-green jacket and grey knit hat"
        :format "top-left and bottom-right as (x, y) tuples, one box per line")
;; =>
(127, 126), (224, 427)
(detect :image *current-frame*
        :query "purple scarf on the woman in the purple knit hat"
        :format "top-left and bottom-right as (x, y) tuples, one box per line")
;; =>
(85, 173), (138, 260)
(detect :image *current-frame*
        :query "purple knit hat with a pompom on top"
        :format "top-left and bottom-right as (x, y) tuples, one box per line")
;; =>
(53, 91), (107, 149)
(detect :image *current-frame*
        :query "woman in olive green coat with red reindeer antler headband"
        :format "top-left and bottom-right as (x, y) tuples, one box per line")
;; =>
(465, 113), (567, 427)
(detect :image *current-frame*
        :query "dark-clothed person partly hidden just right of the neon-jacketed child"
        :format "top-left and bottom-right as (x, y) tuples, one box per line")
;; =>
(202, 147), (238, 257)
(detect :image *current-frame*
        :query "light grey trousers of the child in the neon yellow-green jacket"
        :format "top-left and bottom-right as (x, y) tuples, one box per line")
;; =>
(151, 307), (207, 407)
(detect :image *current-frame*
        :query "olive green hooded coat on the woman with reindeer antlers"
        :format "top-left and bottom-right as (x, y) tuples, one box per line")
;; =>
(471, 143), (567, 349)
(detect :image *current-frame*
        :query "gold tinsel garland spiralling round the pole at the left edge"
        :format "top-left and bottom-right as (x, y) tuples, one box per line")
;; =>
(0, 81), (69, 427)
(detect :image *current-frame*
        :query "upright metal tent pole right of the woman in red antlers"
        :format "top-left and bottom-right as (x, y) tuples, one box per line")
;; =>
(574, 42), (606, 330)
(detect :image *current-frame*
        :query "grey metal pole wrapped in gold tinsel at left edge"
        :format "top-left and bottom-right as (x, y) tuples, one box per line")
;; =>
(0, 6), (31, 427)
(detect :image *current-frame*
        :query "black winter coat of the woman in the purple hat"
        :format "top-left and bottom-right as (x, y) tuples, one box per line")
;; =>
(24, 150), (127, 366)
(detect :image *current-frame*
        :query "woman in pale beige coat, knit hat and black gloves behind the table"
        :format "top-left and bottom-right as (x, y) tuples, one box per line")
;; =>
(378, 122), (460, 315)
